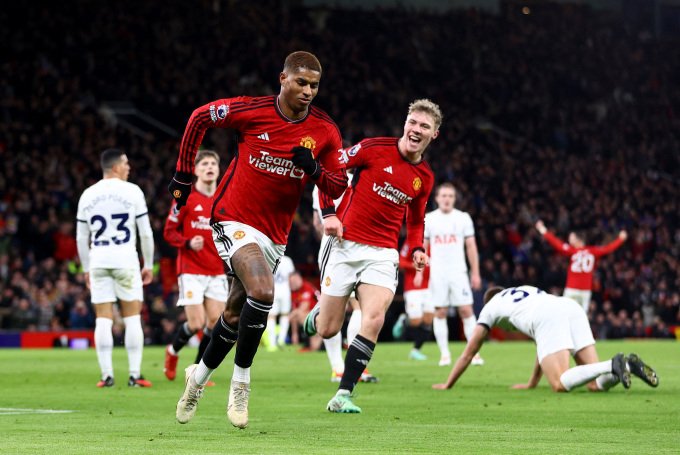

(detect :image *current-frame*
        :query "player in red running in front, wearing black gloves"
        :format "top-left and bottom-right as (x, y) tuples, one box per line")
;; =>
(168, 51), (347, 428)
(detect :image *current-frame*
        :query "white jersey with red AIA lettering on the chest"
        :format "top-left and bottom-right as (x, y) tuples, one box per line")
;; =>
(424, 209), (475, 275)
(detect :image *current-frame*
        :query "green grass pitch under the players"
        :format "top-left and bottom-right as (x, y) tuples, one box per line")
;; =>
(0, 341), (680, 454)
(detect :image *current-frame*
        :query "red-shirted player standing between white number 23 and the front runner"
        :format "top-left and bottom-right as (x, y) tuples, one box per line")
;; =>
(163, 150), (229, 380)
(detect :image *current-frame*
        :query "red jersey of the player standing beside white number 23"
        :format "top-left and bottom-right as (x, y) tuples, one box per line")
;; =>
(163, 190), (224, 276)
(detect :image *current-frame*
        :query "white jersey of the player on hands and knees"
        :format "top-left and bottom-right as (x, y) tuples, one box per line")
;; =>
(477, 286), (564, 339)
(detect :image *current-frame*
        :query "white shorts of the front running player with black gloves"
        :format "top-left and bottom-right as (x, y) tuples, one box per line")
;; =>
(212, 221), (286, 273)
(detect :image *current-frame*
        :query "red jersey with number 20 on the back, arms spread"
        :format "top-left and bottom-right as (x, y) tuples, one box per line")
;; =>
(545, 231), (623, 291)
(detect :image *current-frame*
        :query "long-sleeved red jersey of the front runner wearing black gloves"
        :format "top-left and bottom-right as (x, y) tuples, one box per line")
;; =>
(177, 95), (347, 245)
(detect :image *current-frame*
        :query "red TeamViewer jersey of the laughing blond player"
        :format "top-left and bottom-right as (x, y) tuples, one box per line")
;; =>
(319, 138), (434, 253)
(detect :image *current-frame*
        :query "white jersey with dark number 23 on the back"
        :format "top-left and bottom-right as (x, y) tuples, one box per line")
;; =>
(76, 178), (151, 270)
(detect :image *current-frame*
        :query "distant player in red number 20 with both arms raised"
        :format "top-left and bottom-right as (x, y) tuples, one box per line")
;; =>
(536, 220), (628, 314)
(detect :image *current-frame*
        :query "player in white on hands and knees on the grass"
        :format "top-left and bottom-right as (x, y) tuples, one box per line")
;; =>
(432, 286), (659, 392)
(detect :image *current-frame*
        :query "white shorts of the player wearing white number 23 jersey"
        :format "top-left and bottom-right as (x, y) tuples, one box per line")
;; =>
(90, 269), (144, 304)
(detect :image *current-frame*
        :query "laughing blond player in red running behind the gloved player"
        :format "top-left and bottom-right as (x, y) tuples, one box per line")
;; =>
(304, 99), (442, 412)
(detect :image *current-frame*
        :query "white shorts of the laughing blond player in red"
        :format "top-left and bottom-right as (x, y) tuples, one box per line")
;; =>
(319, 238), (399, 297)
